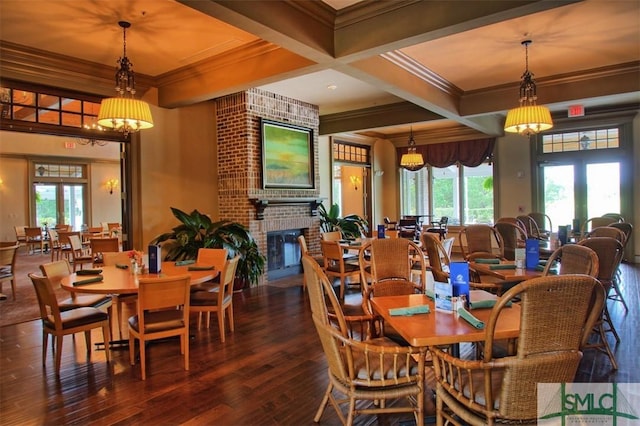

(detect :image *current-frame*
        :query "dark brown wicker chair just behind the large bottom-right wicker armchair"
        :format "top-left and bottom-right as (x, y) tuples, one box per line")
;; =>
(578, 237), (622, 370)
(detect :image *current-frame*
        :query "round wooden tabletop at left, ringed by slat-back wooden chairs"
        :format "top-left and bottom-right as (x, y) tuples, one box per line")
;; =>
(61, 262), (220, 294)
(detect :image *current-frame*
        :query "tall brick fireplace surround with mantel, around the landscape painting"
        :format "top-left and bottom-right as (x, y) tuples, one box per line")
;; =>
(216, 89), (320, 285)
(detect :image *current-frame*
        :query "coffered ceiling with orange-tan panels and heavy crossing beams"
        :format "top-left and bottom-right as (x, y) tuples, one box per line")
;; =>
(0, 0), (640, 139)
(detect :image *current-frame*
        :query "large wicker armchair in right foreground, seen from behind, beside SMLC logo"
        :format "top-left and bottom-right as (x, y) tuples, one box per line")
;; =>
(429, 275), (605, 425)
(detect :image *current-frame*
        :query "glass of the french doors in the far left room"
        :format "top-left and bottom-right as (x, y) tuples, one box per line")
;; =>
(33, 183), (88, 230)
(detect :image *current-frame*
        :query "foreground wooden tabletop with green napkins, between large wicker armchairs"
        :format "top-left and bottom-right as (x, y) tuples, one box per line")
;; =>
(371, 290), (520, 347)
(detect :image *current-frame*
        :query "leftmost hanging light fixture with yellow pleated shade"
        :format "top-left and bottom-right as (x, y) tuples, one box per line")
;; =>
(98, 21), (153, 136)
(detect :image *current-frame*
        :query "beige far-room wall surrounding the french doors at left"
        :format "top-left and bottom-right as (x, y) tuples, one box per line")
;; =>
(0, 131), (121, 241)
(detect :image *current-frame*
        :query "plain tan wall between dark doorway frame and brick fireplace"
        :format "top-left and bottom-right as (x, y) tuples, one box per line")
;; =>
(133, 102), (219, 250)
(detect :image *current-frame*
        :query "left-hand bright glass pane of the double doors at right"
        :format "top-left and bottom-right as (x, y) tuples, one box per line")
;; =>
(543, 165), (575, 232)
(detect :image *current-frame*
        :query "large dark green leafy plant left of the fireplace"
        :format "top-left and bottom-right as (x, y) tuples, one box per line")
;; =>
(151, 207), (266, 286)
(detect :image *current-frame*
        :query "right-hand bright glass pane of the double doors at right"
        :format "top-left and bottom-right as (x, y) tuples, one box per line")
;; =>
(586, 162), (620, 219)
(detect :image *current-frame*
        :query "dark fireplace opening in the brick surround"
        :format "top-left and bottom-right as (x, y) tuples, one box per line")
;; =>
(267, 229), (302, 280)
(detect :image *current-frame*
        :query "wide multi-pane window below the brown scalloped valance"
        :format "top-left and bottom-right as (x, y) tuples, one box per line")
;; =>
(400, 163), (493, 224)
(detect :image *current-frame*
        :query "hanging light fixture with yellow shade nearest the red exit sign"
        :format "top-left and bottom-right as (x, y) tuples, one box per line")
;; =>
(504, 40), (553, 136)
